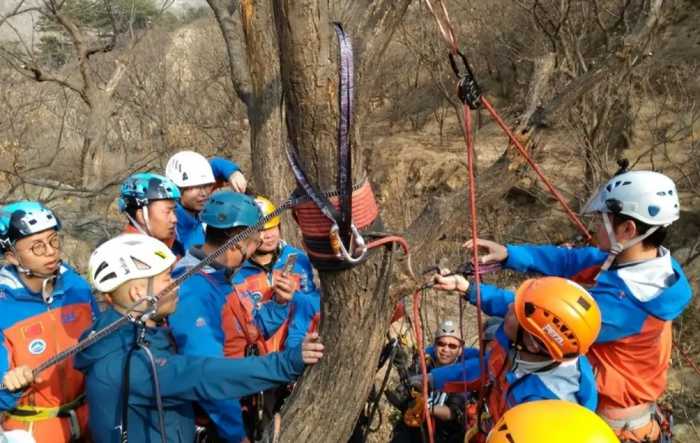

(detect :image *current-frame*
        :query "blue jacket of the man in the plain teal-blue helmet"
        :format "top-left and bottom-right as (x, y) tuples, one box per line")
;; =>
(168, 248), (287, 442)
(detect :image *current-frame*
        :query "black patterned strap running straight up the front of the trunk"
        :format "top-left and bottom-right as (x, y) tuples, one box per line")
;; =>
(334, 23), (355, 248)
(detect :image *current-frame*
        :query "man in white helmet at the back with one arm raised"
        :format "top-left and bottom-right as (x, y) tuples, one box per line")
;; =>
(165, 151), (247, 250)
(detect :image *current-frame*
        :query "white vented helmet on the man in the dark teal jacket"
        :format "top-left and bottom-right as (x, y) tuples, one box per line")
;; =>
(88, 234), (176, 292)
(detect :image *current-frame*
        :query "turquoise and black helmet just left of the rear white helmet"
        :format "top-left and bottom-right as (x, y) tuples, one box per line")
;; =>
(119, 172), (180, 212)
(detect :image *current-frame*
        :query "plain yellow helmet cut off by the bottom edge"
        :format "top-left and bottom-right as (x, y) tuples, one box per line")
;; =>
(486, 400), (619, 443)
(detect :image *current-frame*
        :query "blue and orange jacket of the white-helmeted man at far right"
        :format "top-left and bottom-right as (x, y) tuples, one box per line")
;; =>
(494, 245), (692, 408)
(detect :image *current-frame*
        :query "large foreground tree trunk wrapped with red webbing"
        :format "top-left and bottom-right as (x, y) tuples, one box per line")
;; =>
(262, 0), (409, 443)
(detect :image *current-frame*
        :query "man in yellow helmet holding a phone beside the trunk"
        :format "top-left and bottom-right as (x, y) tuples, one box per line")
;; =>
(222, 197), (320, 439)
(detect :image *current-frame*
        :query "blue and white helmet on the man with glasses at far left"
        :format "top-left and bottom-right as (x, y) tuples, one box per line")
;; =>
(0, 200), (61, 252)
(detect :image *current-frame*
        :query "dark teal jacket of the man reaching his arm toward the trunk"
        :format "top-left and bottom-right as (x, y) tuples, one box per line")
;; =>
(75, 309), (304, 443)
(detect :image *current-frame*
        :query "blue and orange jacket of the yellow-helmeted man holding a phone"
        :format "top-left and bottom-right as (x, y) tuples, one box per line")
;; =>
(233, 241), (321, 347)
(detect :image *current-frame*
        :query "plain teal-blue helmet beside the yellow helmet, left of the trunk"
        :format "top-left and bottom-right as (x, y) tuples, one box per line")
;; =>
(199, 190), (262, 229)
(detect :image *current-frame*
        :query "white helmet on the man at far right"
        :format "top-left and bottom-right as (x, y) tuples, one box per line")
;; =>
(583, 171), (680, 226)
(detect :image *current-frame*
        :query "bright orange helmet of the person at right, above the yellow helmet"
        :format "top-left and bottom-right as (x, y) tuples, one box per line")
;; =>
(514, 277), (600, 361)
